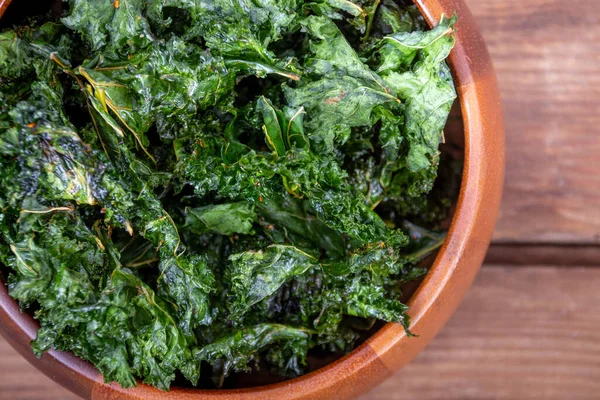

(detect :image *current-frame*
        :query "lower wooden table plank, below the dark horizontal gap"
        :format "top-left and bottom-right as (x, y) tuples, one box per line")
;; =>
(0, 266), (600, 400)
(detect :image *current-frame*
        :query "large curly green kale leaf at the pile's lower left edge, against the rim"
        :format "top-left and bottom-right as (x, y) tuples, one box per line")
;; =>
(2, 208), (199, 389)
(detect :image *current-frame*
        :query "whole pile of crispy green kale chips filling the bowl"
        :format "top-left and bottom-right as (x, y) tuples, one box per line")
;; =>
(0, 0), (455, 390)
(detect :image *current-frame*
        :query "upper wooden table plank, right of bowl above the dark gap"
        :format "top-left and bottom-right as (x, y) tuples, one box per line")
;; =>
(467, 0), (600, 244)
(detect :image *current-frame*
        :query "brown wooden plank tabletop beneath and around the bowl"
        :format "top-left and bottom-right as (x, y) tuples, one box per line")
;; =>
(0, 0), (600, 400)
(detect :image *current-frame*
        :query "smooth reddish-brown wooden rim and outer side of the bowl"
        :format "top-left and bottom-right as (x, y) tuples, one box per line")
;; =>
(0, 0), (504, 400)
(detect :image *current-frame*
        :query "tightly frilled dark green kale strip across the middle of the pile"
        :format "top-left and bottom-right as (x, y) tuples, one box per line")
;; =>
(183, 135), (405, 245)
